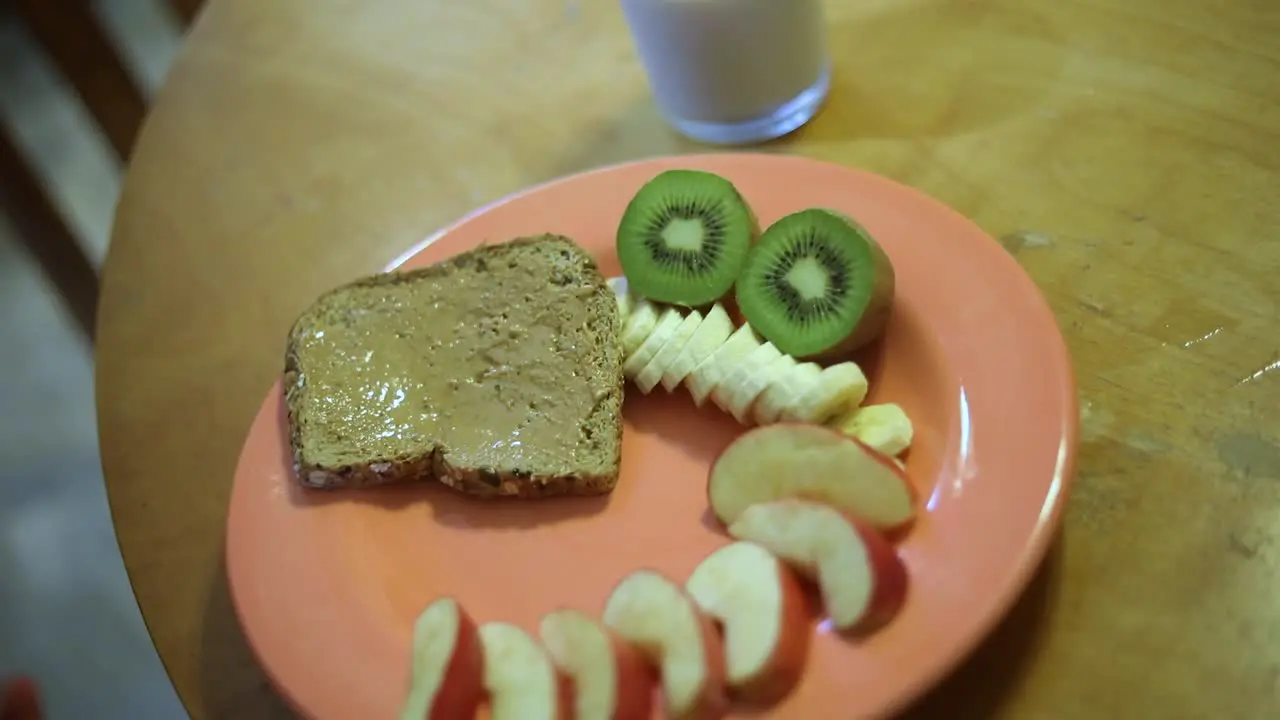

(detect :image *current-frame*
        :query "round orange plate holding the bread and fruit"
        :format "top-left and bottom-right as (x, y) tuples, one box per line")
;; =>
(227, 155), (1078, 719)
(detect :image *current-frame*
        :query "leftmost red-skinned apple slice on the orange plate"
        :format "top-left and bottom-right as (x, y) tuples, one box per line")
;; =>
(399, 597), (484, 720)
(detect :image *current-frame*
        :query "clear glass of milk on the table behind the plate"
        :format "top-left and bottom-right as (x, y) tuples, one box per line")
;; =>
(621, 0), (831, 145)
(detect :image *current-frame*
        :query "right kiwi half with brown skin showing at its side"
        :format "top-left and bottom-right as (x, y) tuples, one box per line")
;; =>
(735, 208), (893, 361)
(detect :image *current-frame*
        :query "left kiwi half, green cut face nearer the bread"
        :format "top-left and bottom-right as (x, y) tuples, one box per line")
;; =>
(617, 170), (758, 307)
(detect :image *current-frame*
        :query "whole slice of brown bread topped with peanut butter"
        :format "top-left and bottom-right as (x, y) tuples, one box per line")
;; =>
(284, 234), (623, 497)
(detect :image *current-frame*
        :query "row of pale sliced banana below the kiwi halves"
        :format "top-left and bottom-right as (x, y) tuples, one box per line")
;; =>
(609, 278), (913, 456)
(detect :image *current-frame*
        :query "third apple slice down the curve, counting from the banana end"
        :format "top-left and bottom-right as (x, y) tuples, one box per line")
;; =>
(685, 542), (809, 702)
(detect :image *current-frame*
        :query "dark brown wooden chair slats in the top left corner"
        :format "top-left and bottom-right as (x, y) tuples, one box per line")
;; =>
(0, 0), (202, 341)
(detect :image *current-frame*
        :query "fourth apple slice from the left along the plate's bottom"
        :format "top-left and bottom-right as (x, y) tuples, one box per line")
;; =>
(604, 570), (728, 720)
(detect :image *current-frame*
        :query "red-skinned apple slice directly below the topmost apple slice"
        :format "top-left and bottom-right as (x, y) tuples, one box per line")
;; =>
(728, 500), (908, 627)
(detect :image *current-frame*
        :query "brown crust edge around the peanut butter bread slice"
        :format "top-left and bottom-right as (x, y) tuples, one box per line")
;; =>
(283, 234), (625, 498)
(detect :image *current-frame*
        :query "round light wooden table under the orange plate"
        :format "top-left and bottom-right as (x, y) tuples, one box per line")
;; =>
(97, 0), (1280, 720)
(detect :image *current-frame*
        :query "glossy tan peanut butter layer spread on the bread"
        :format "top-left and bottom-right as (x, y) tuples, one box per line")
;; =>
(294, 240), (617, 474)
